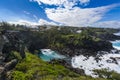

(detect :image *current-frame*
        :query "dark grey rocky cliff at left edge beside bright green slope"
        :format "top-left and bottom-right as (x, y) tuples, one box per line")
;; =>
(0, 32), (25, 80)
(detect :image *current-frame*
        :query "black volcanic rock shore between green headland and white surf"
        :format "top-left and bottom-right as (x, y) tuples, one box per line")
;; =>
(52, 41), (113, 56)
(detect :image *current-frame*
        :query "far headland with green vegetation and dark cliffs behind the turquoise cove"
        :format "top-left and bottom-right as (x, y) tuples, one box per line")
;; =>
(0, 22), (118, 53)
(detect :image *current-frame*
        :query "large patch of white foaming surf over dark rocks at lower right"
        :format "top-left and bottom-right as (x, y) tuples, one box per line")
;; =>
(71, 53), (120, 77)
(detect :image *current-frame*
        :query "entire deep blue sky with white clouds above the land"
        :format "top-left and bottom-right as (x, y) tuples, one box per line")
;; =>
(0, 0), (120, 28)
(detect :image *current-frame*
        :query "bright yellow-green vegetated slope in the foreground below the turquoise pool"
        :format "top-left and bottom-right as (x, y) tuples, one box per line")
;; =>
(8, 52), (112, 80)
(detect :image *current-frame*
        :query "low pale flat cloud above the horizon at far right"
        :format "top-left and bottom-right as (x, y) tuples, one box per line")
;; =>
(92, 21), (120, 28)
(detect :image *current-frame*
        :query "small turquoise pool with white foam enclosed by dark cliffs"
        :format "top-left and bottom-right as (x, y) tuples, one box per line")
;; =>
(39, 49), (65, 61)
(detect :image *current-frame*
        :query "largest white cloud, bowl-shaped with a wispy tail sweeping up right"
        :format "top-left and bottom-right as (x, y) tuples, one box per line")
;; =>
(45, 5), (116, 26)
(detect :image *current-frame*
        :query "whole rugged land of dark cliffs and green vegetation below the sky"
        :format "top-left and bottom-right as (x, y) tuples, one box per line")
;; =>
(0, 22), (120, 80)
